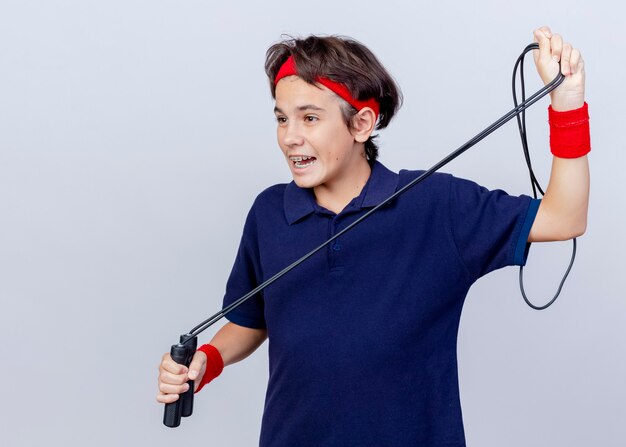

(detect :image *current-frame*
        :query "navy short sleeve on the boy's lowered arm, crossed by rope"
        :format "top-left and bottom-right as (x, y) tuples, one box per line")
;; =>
(223, 207), (266, 329)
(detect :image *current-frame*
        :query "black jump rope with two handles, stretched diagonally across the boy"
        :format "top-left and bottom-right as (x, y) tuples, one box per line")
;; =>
(163, 43), (576, 427)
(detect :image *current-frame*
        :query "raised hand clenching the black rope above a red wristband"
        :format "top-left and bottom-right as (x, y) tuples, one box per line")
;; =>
(533, 26), (585, 111)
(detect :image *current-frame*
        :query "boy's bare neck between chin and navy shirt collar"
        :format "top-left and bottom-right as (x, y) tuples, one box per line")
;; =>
(313, 157), (372, 214)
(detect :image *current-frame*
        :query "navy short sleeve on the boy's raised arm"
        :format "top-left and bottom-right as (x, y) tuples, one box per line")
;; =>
(450, 177), (541, 279)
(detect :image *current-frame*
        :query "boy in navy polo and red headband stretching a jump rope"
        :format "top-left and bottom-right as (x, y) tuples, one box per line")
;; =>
(157, 27), (589, 447)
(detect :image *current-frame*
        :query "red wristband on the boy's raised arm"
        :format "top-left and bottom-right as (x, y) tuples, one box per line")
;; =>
(548, 103), (591, 158)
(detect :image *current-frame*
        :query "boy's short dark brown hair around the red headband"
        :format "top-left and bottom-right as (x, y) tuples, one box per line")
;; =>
(265, 36), (402, 163)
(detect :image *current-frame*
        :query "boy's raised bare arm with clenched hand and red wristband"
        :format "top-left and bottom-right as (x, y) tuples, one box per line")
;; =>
(528, 27), (589, 242)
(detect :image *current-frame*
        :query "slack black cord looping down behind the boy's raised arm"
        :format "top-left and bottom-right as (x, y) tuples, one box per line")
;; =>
(512, 43), (576, 310)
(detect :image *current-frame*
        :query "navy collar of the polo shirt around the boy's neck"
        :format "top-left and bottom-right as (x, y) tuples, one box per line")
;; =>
(284, 161), (398, 225)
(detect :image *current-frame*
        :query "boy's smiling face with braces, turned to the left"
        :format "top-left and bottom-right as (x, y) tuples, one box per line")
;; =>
(274, 76), (367, 188)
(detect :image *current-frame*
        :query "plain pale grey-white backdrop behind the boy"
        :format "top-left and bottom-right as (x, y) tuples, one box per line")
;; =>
(0, 0), (626, 447)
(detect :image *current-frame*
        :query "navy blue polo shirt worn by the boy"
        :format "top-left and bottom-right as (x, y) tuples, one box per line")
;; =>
(224, 162), (540, 447)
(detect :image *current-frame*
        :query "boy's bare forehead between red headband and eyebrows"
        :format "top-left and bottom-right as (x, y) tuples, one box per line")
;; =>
(275, 76), (339, 112)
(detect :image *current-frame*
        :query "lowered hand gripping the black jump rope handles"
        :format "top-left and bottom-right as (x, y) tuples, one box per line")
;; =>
(157, 351), (207, 404)
